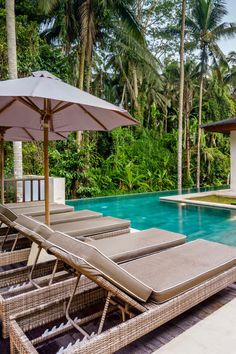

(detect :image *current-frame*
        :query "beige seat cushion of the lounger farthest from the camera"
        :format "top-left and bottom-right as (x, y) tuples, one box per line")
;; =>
(12, 203), (74, 216)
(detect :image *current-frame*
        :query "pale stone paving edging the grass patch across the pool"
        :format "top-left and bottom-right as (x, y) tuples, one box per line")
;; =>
(160, 189), (236, 210)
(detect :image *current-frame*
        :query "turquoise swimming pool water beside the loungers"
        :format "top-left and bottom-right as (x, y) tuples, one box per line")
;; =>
(67, 191), (236, 246)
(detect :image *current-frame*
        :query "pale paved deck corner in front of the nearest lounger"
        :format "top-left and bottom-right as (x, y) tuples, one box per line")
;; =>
(154, 299), (236, 354)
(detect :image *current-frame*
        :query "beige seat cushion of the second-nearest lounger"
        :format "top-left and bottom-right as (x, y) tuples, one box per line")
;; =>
(86, 228), (186, 262)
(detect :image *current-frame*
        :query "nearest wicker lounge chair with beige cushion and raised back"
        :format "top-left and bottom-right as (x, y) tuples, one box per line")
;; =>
(10, 233), (236, 354)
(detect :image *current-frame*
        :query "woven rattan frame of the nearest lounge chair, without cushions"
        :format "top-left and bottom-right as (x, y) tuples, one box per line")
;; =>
(10, 267), (236, 354)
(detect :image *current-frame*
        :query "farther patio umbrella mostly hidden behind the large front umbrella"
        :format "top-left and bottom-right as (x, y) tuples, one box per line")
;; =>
(0, 127), (68, 204)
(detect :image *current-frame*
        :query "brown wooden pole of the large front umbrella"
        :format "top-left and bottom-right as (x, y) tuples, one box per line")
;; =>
(43, 118), (50, 225)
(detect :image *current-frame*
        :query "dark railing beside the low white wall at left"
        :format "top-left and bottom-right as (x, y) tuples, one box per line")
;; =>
(4, 176), (44, 203)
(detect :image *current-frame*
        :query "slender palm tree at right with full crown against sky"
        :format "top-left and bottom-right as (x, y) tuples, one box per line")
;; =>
(186, 0), (236, 188)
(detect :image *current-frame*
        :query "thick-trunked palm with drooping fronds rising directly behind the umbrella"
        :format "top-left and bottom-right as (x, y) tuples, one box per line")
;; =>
(39, 0), (144, 145)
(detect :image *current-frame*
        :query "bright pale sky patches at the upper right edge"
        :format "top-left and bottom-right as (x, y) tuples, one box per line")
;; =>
(219, 0), (236, 54)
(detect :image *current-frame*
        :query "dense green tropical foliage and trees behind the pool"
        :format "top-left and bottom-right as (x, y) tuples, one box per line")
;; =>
(0, 0), (236, 198)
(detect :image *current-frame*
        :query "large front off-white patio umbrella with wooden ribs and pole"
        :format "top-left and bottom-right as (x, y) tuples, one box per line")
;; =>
(0, 71), (137, 224)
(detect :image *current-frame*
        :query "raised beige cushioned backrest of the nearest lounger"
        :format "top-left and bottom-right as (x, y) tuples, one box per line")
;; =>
(42, 232), (152, 301)
